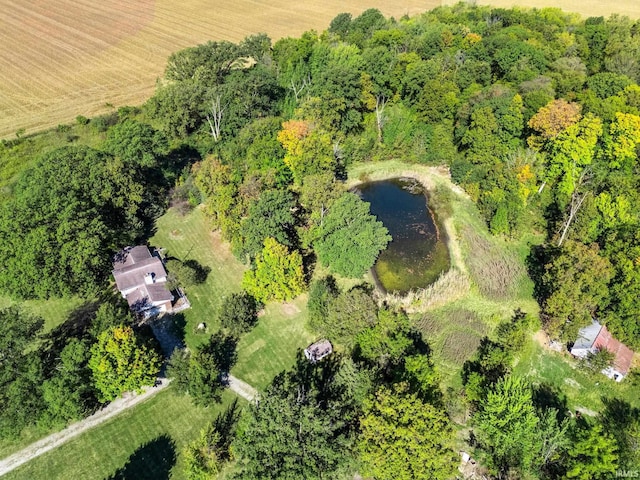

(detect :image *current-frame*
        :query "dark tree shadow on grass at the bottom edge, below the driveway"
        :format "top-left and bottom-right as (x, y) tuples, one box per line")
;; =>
(106, 435), (177, 480)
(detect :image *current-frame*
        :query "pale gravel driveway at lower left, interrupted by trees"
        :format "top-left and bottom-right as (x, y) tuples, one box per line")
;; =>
(0, 375), (258, 476)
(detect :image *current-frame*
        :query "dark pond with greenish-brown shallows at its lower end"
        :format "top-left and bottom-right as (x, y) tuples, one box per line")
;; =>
(357, 177), (449, 293)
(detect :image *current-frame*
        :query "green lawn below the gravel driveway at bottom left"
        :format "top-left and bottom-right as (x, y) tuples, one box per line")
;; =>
(4, 387), (236, 480)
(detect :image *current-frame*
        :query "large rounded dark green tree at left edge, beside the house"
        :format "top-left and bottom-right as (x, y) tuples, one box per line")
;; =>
(0, 147), (145, 298)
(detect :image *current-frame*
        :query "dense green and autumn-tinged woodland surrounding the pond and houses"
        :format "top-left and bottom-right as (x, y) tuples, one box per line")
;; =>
(0, 4), (640, 480)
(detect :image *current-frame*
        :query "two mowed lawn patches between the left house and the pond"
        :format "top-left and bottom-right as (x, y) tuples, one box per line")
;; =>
(151, 205), (314, 389)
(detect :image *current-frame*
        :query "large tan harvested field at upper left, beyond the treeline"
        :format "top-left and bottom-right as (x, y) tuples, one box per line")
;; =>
(0, 0), (440, 138)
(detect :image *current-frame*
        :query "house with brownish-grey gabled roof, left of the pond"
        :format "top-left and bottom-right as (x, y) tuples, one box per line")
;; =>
(112, 245), (173, 317)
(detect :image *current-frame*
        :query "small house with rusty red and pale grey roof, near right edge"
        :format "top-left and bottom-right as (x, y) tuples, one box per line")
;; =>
(571, 320), (633, 382)
